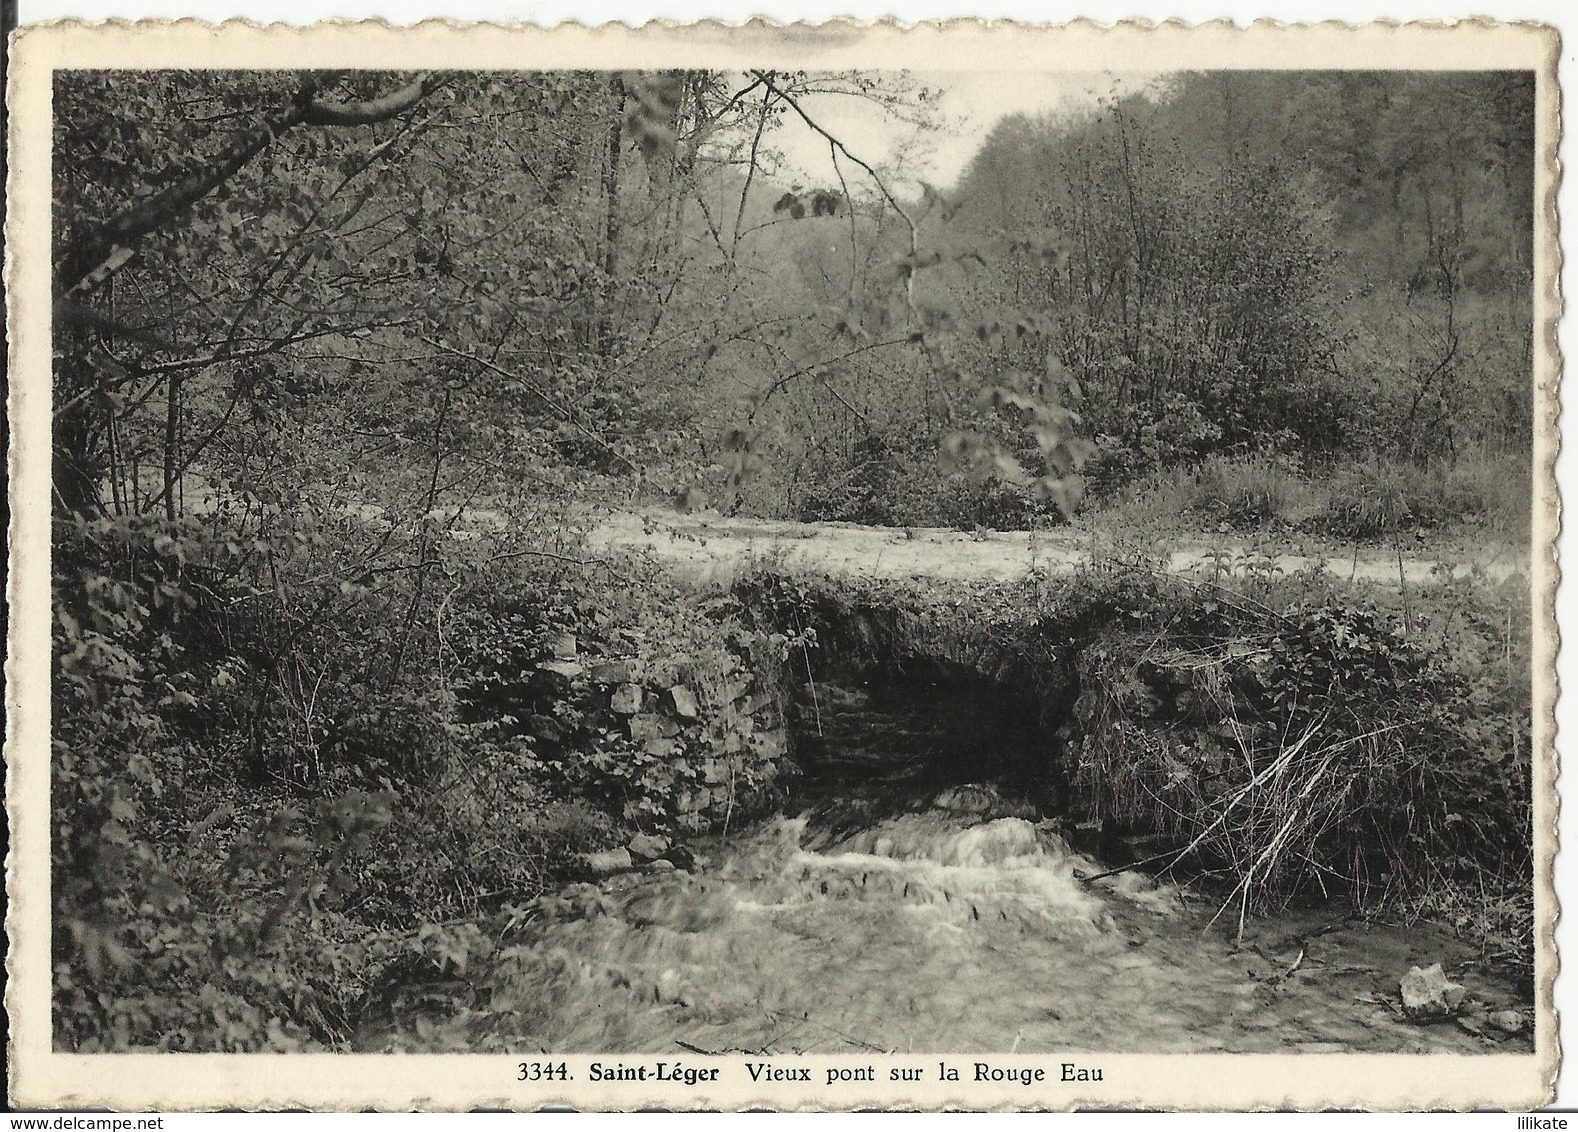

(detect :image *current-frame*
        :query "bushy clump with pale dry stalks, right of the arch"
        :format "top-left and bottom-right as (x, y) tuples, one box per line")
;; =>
(1076, 574), (1532, 947)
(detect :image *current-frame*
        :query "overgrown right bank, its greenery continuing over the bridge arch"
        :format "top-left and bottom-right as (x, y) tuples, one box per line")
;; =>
(746, 556), (1534, 965)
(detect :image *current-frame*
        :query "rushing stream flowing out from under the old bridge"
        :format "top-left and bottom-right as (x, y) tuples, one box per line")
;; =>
(374, 685), (1532, 1055)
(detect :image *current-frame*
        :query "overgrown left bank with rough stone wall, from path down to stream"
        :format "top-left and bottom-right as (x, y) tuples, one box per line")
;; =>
(52, 502), (801, 1050)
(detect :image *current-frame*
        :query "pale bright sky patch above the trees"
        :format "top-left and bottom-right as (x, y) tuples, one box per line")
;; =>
(773, 71), (1157, 193)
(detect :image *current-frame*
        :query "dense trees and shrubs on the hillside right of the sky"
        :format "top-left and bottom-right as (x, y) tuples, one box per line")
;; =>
(921, 73), (1534, 508)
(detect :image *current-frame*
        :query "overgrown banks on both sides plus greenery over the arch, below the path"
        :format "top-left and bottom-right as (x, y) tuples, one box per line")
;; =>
(55, 514), (1532, 1050)
